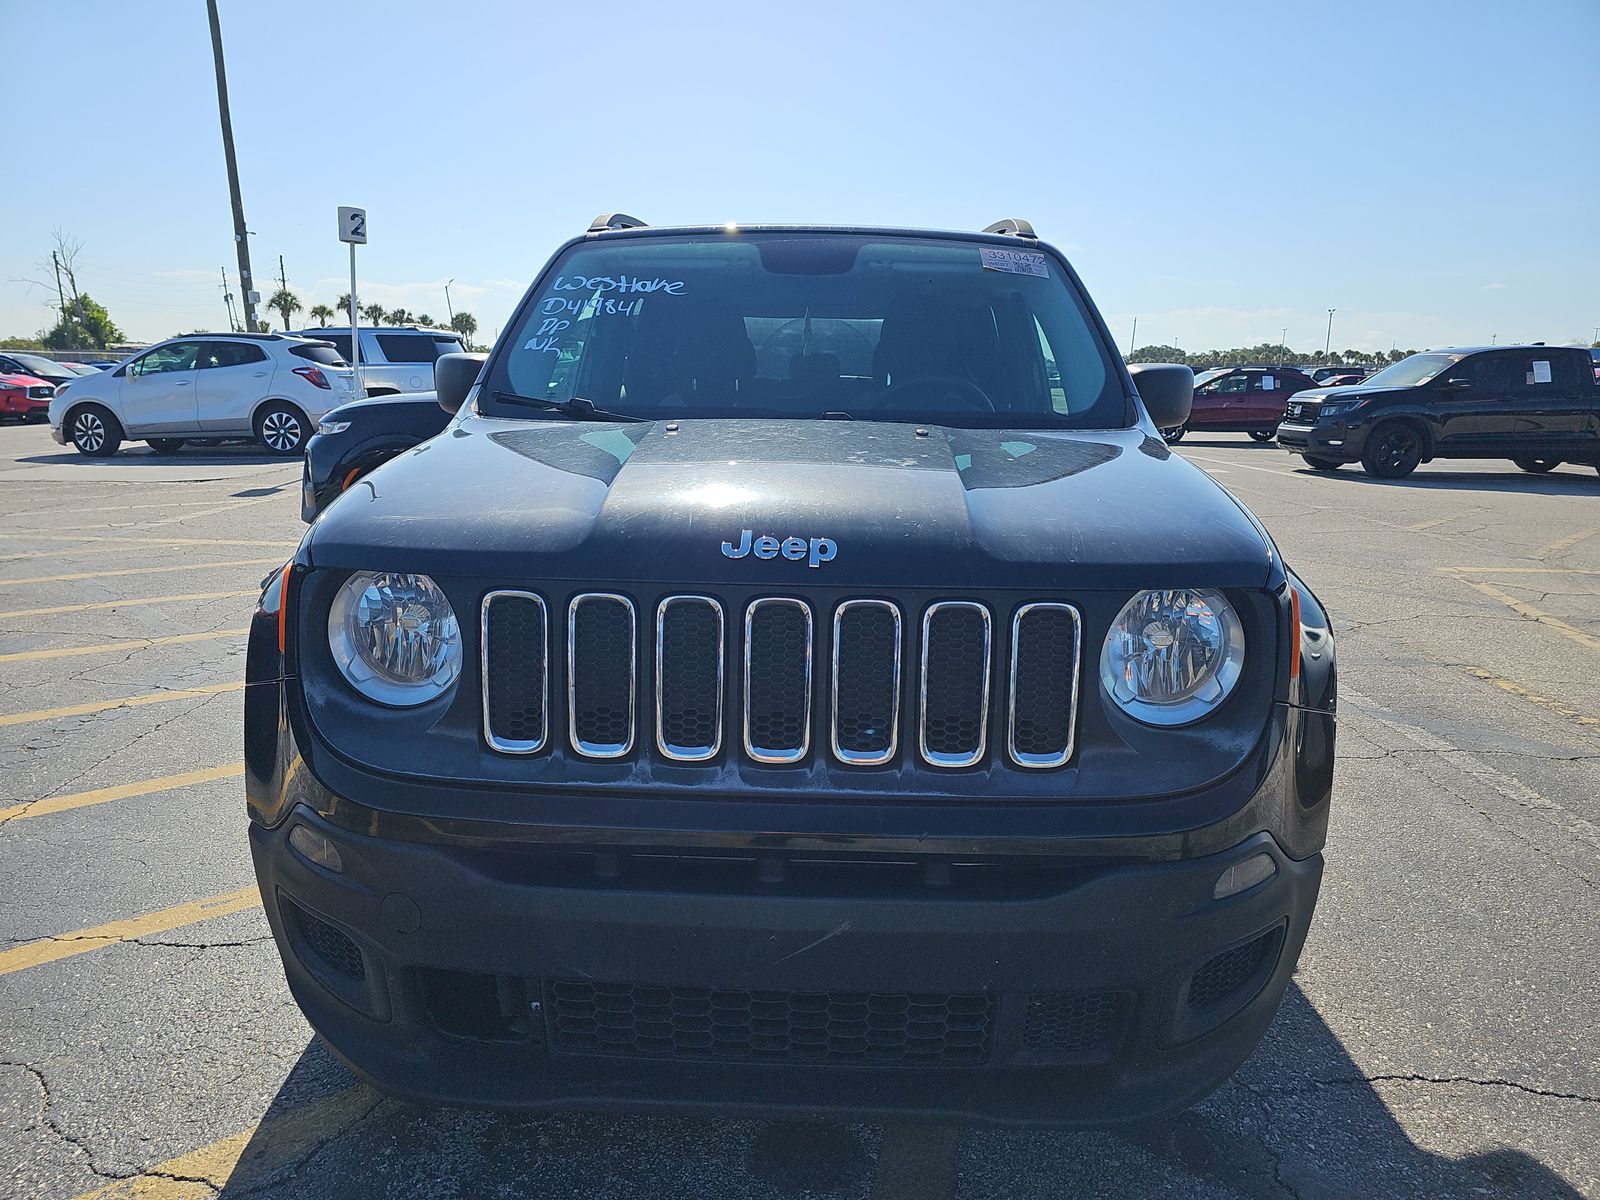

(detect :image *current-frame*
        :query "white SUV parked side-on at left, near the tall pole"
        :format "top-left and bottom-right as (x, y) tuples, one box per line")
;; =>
(50, 333), (355, 458)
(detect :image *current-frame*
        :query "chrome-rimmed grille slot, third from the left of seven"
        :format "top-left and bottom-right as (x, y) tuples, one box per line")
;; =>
(656, 595), (725, 762)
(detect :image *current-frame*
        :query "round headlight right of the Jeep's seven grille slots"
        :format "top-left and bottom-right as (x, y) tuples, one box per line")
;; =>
(1101, 587), (1245, 725)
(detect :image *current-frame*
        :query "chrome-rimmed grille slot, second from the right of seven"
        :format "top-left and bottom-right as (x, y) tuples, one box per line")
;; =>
(918, 600), (994, 766)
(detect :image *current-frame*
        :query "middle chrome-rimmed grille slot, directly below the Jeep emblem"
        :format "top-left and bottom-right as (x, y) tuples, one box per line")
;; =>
(744, 597), (811, 763)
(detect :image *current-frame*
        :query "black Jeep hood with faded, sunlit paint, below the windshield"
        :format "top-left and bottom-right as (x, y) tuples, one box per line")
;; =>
(304, 416), (1277, 594)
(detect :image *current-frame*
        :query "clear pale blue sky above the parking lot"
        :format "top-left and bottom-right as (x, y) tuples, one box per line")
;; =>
(0, 0), (1600, 350)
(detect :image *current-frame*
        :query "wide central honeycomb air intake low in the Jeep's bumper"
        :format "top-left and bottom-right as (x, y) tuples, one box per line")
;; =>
(546, 981), (992, 1066)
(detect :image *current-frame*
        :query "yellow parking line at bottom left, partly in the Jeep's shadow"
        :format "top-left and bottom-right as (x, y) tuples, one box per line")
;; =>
(65, 1083), (382, 1200)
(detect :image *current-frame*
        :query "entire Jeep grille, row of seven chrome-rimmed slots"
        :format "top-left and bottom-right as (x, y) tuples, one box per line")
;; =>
(482, 590), (1082, 770)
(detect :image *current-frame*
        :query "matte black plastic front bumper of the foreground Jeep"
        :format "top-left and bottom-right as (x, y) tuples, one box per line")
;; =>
(250, 805), (1322, 1126)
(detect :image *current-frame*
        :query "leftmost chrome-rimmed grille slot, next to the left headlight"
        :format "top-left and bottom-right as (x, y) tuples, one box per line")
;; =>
(478, 590), (550, 754)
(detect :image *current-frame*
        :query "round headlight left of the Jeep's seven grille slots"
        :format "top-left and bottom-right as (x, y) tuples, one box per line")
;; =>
(328, 571), (461, 707)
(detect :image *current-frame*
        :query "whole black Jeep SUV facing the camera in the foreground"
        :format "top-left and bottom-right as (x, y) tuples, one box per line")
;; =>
(245, 214), (1334, 1125)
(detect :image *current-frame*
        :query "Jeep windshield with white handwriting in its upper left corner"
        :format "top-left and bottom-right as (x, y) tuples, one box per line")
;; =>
(480, 234), (1133, 429)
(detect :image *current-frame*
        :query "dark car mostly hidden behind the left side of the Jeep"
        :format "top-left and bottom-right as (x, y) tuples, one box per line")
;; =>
(301, 390), (464, 522)
